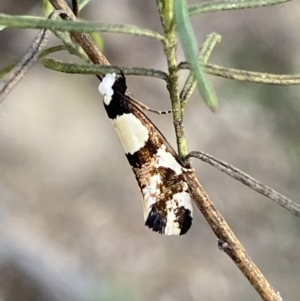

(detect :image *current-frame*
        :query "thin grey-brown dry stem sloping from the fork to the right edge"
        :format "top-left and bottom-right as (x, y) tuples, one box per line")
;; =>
(187, 152), (300, 217)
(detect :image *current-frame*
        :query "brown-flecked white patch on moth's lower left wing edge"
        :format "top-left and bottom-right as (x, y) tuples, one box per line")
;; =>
(142, 174), (162, 221)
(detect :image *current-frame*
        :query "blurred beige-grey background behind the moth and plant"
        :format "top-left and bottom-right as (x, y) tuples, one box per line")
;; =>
(0, 0), (300, 301)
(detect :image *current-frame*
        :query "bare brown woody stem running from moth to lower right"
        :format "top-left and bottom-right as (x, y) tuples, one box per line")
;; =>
(185, 173), (280, 301)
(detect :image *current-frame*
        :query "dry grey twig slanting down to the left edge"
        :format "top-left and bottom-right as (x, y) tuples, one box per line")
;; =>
(0, 13), (51, 104)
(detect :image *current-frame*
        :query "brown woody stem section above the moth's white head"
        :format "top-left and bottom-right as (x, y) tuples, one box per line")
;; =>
(49, 0), (110, 65)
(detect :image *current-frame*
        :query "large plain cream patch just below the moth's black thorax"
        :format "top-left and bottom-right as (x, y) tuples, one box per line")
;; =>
(112, 113), (149, 154)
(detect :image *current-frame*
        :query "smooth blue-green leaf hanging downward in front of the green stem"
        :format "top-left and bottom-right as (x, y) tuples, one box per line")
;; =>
(174, 0), (218, 111)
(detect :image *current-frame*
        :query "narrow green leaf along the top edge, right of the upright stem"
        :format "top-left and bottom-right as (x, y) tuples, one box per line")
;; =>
(188, 0), (292, 17)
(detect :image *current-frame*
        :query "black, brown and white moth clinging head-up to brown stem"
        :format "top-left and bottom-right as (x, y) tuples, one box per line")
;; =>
(99, 73), (193, 235)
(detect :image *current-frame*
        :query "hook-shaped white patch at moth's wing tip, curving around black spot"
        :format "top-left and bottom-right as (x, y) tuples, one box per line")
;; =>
(164, 191), (193, 235)
